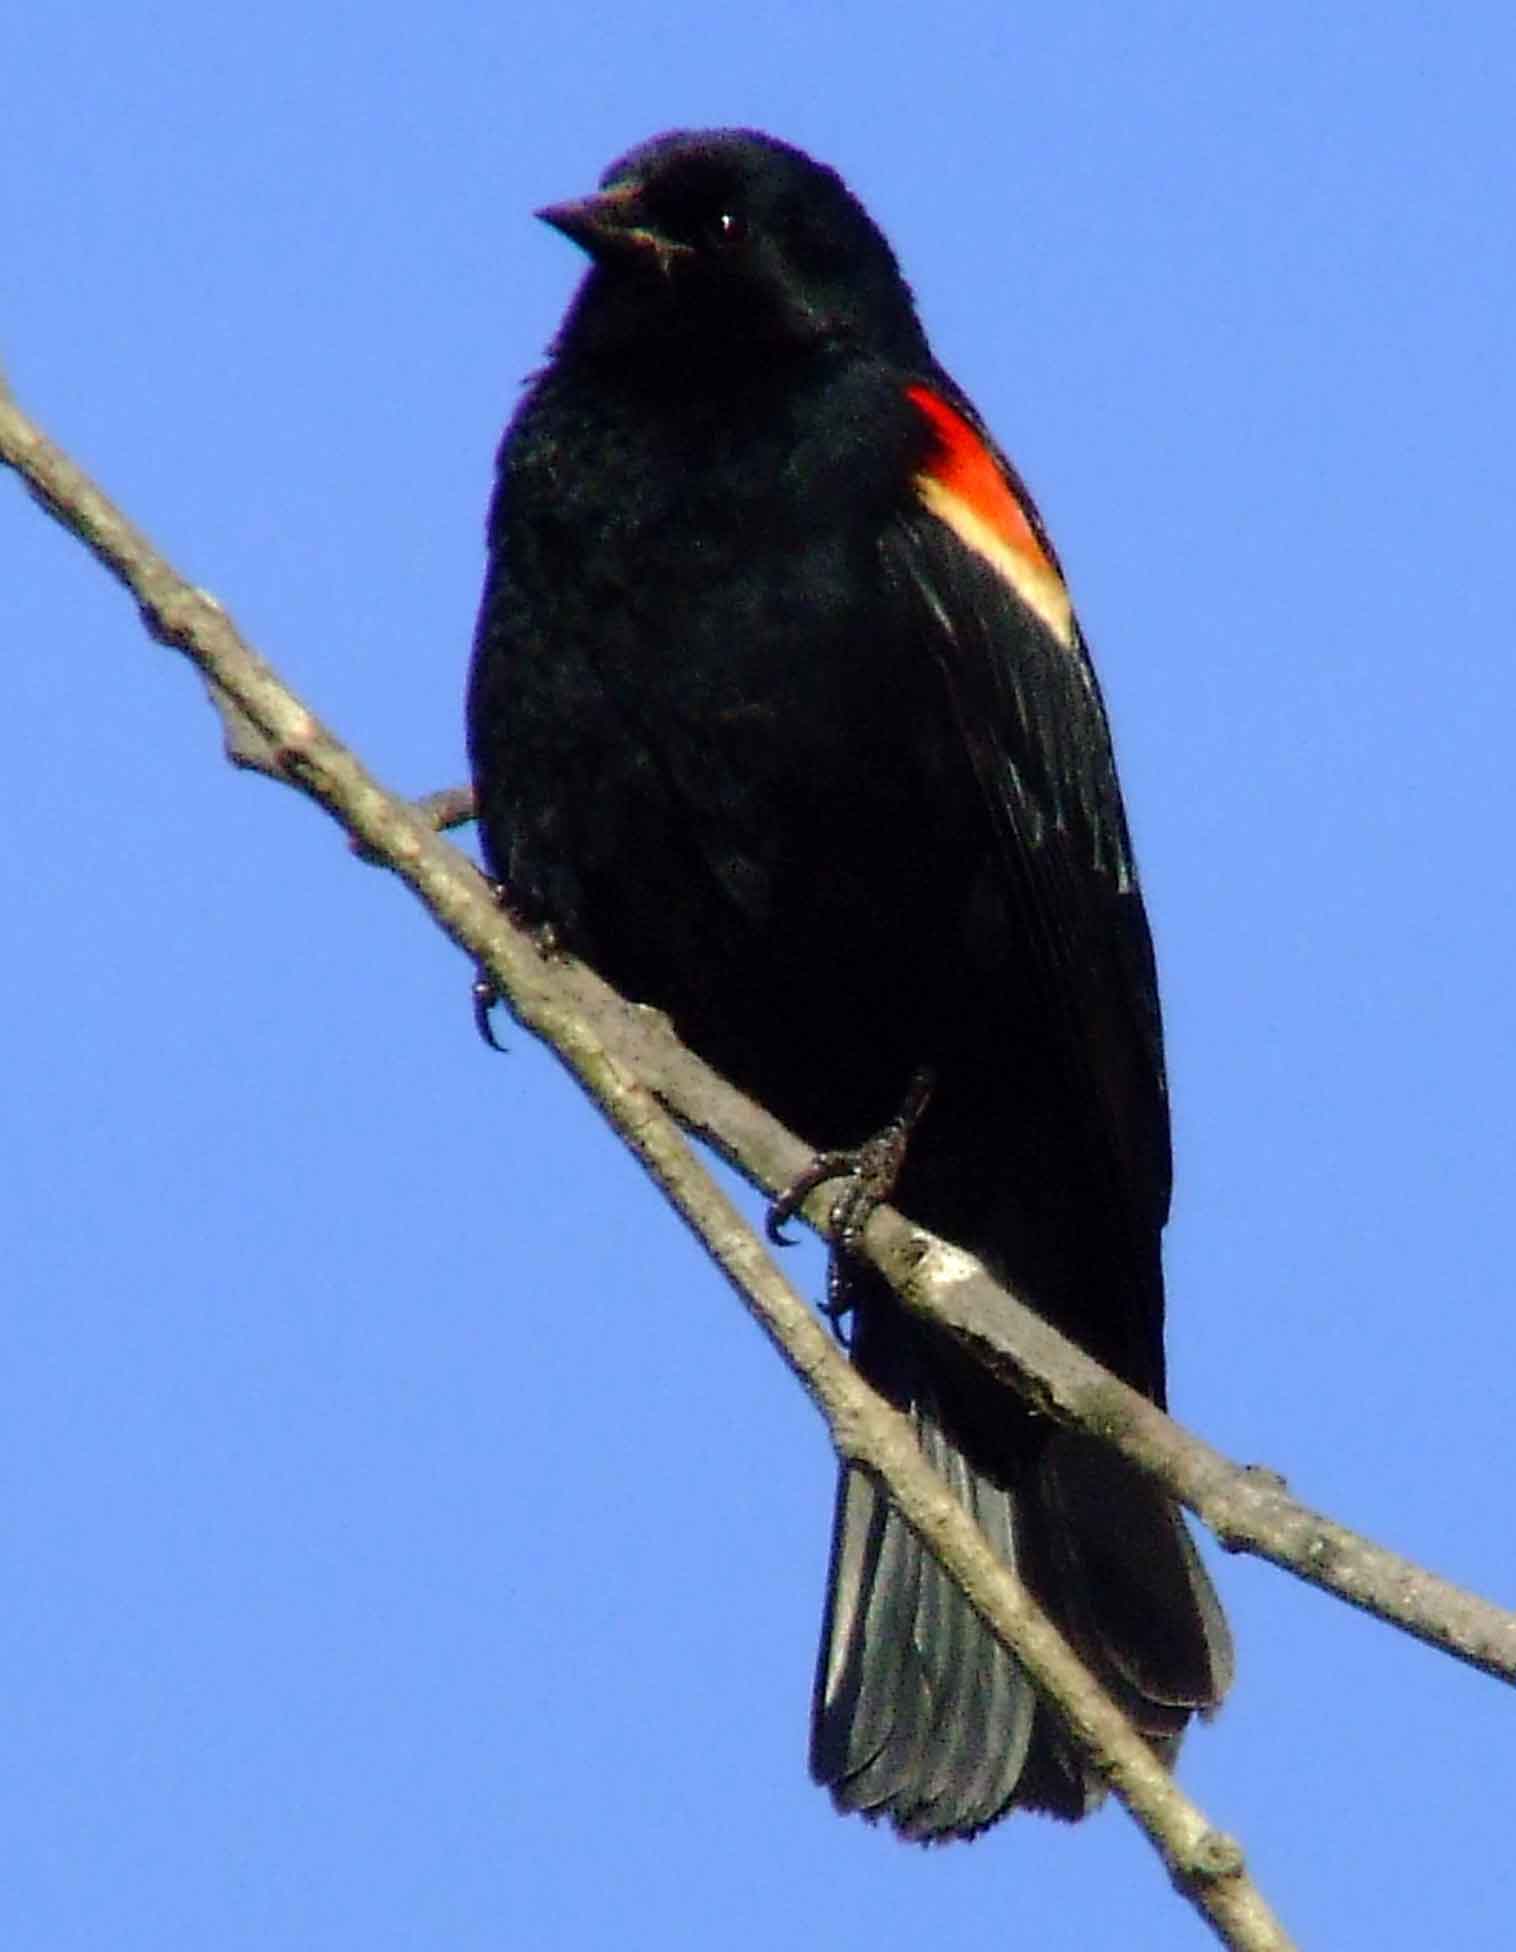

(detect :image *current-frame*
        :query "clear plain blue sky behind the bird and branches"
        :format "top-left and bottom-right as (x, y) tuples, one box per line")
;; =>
(0, 0), (1516, 1952)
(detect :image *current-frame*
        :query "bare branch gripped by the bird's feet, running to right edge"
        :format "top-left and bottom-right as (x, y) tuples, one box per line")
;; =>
(0, 392), (1475, 1709)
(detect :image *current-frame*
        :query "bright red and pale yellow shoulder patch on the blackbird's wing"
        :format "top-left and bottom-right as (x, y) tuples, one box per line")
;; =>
(905, 385), (1075, 648)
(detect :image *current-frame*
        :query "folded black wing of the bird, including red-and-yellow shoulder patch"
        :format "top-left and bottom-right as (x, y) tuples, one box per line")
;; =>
(884, 375), (1171, 1303)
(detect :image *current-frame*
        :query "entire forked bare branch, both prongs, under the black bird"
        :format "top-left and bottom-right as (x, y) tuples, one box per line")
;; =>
(0, 380), (1490, 1952)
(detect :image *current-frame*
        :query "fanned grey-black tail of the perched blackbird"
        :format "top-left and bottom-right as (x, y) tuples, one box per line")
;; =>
(812, 1304), (1231, 1843)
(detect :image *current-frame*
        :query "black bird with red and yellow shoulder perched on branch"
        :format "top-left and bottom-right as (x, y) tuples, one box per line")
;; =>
(468, 131), (1231, 1839)
